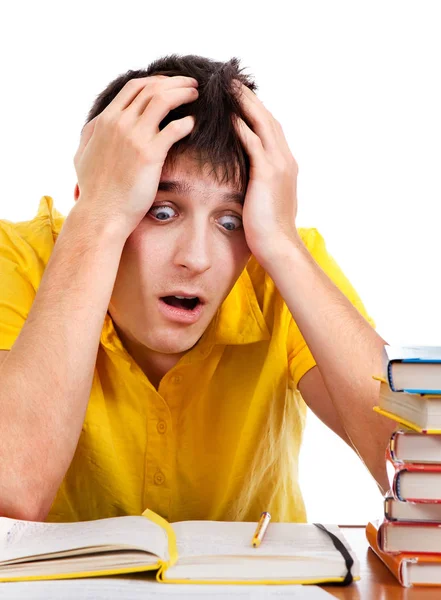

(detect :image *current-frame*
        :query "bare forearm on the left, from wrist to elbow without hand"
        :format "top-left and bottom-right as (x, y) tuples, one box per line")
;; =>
(0, 204), (124, 518)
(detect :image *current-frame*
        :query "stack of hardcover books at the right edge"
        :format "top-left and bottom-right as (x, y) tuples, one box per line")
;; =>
(366, 346), (441, 587)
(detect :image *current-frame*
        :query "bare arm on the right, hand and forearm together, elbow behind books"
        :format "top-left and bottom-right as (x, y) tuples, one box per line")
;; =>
(229, 78), (392, 486)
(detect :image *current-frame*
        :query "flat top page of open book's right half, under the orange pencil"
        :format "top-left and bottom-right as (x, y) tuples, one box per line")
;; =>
(173, 521), (348, 562)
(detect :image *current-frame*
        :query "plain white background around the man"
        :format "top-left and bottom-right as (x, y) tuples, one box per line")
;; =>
(0, 0), (441, 523)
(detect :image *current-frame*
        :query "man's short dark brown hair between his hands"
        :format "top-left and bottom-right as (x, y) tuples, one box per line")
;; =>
(86, 54), (257, 191)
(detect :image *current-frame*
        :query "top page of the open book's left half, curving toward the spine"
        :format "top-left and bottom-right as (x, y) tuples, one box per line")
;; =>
(0, 516), (168, 564)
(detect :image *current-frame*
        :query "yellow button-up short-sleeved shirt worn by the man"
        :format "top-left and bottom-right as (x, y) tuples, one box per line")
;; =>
(0, 196), (373, 521)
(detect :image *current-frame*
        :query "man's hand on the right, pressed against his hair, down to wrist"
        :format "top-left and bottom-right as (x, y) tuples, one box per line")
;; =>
(234, 82), (299, 266)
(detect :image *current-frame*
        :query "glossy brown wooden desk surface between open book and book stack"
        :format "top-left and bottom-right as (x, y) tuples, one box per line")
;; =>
(323, 527), (441, 600)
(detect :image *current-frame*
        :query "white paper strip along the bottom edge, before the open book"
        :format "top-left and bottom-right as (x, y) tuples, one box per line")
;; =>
(1, 577), (333, 600)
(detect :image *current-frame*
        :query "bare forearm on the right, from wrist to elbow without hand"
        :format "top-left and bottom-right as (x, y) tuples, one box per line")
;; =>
(267, 239), (394, 489)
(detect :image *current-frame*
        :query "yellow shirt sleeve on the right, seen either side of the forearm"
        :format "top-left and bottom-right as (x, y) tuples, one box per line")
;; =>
(288, 229), (375, 388)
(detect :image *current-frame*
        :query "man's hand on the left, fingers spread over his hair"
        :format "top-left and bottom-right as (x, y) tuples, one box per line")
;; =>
(74, 75), (198, 238)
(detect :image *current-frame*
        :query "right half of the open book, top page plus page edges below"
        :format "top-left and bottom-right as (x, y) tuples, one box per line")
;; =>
(162, 521), (359, 584)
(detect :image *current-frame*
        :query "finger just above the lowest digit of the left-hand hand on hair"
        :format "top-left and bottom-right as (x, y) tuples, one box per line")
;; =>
(137, 87), (198, 135)
